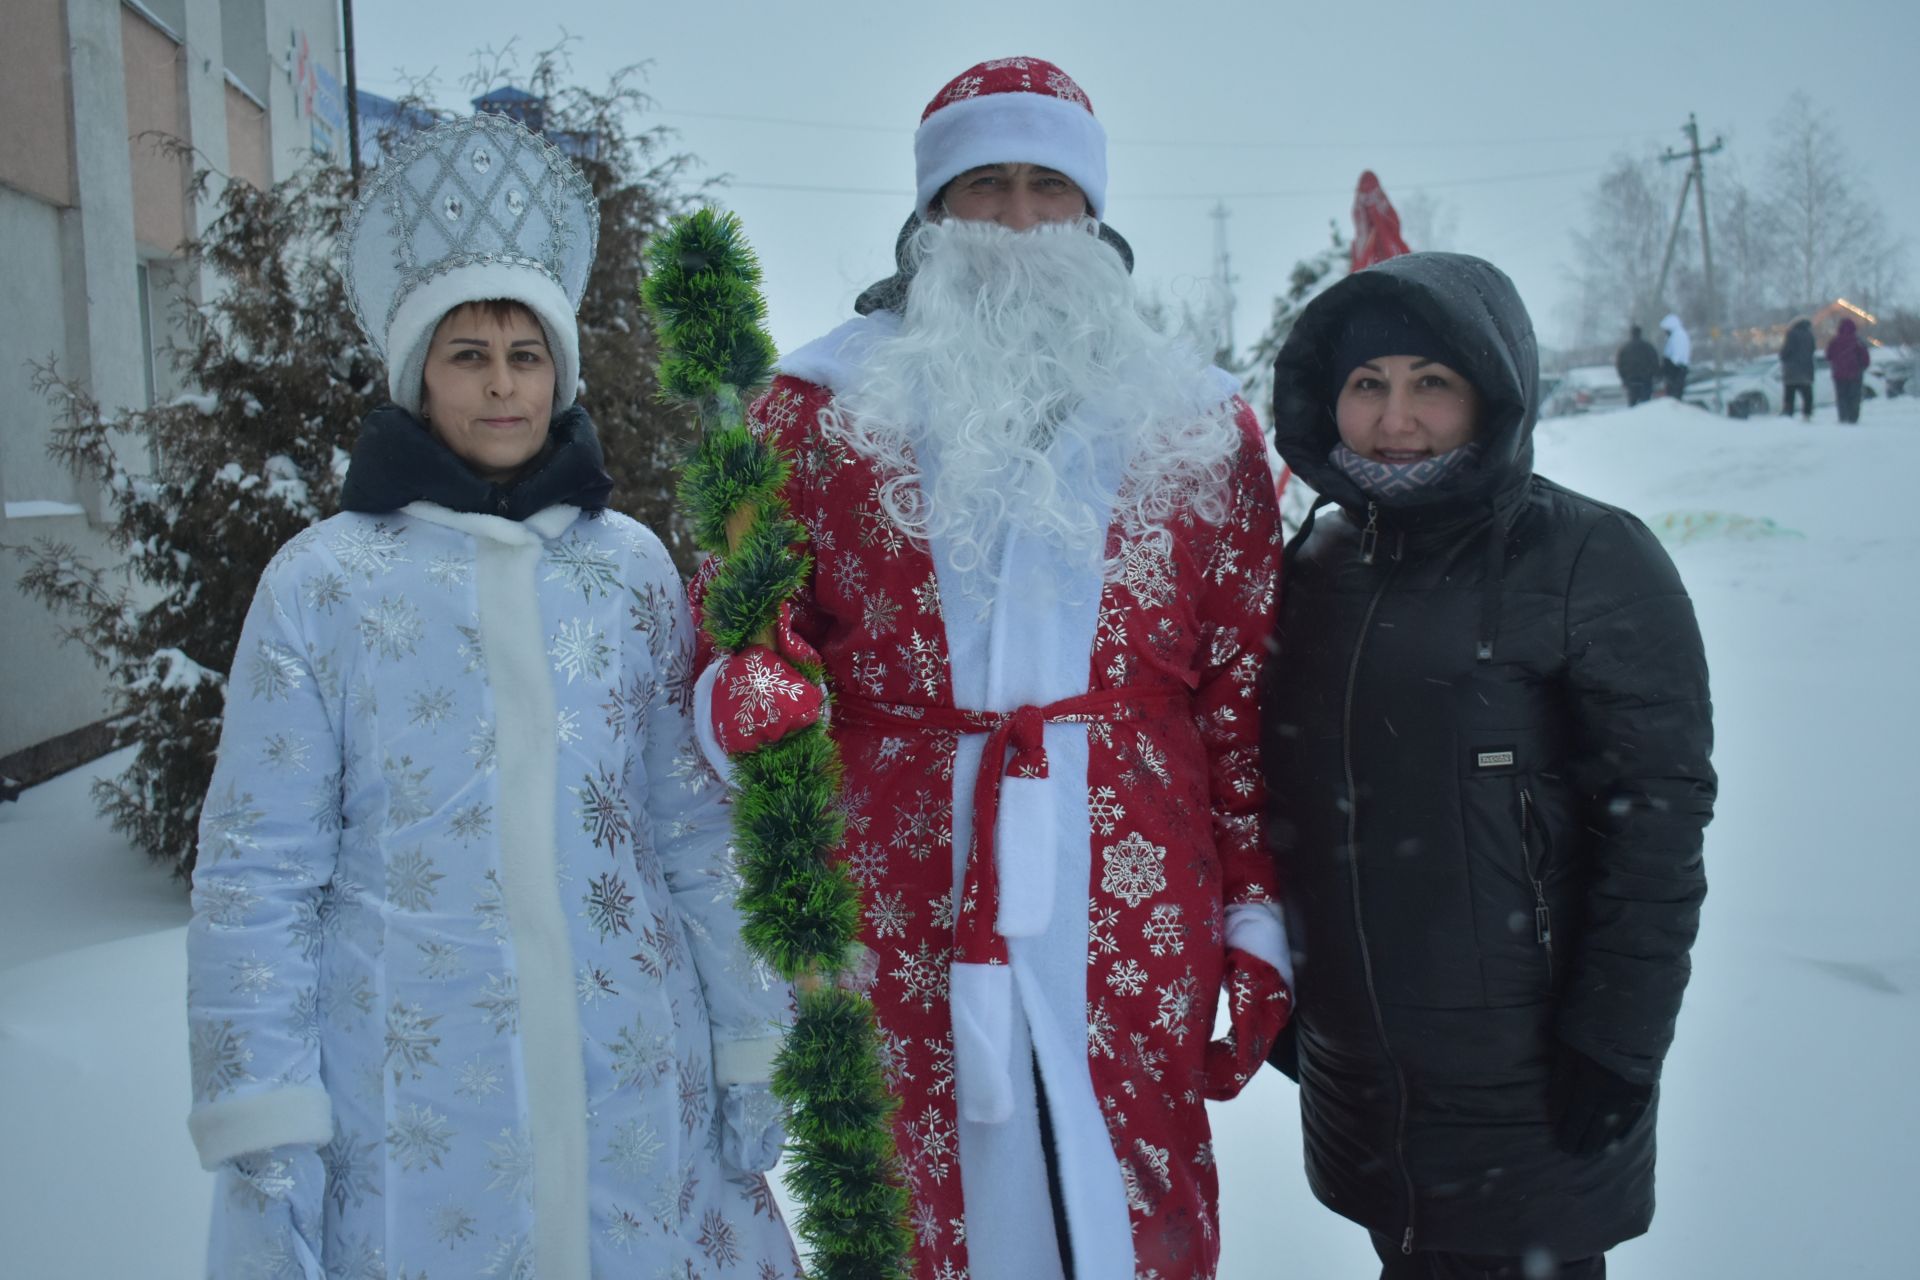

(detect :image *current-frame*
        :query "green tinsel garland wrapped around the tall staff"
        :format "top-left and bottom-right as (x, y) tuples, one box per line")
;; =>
(641, 209), (912, 1280)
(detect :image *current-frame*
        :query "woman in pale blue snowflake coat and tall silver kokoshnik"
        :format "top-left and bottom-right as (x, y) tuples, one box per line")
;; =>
(188, 115), (799, 1280)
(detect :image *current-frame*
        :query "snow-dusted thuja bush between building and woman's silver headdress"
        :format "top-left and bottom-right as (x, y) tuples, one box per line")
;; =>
(13, 167), (386, 875)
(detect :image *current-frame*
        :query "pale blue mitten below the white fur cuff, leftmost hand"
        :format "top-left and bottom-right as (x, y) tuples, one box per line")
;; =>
(207, 1146), (326, 1280)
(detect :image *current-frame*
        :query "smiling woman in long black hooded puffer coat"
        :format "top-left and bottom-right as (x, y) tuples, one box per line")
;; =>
(1261, 253), (1716, 1280)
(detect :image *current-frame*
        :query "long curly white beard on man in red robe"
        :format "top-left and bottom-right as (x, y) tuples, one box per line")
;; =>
(829, 219), (1238, 601)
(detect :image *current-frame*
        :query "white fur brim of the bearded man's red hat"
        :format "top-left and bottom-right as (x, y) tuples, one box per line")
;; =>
(914, 92), (1106, 217)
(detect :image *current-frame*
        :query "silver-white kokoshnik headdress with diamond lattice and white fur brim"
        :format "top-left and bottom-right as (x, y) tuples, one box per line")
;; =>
(346, 113), (599, 415)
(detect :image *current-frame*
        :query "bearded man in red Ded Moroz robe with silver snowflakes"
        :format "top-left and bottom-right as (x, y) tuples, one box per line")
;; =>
(695, 58), (1292, 1280)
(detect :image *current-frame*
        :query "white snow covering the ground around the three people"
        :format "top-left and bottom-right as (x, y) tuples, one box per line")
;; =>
(0, 399), (1920, 1280)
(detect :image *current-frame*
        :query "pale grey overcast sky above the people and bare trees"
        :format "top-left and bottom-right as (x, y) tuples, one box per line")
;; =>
(355, 0), (1920, 360)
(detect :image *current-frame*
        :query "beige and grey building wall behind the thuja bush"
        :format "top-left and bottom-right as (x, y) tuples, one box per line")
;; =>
(0, 0), (346, 771)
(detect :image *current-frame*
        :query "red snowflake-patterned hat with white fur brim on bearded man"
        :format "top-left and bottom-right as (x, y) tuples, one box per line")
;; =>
(914, 58), (1106, 217)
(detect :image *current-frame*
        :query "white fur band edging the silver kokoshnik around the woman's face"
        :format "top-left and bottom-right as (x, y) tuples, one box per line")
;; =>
(386, 263), (580, 416)
